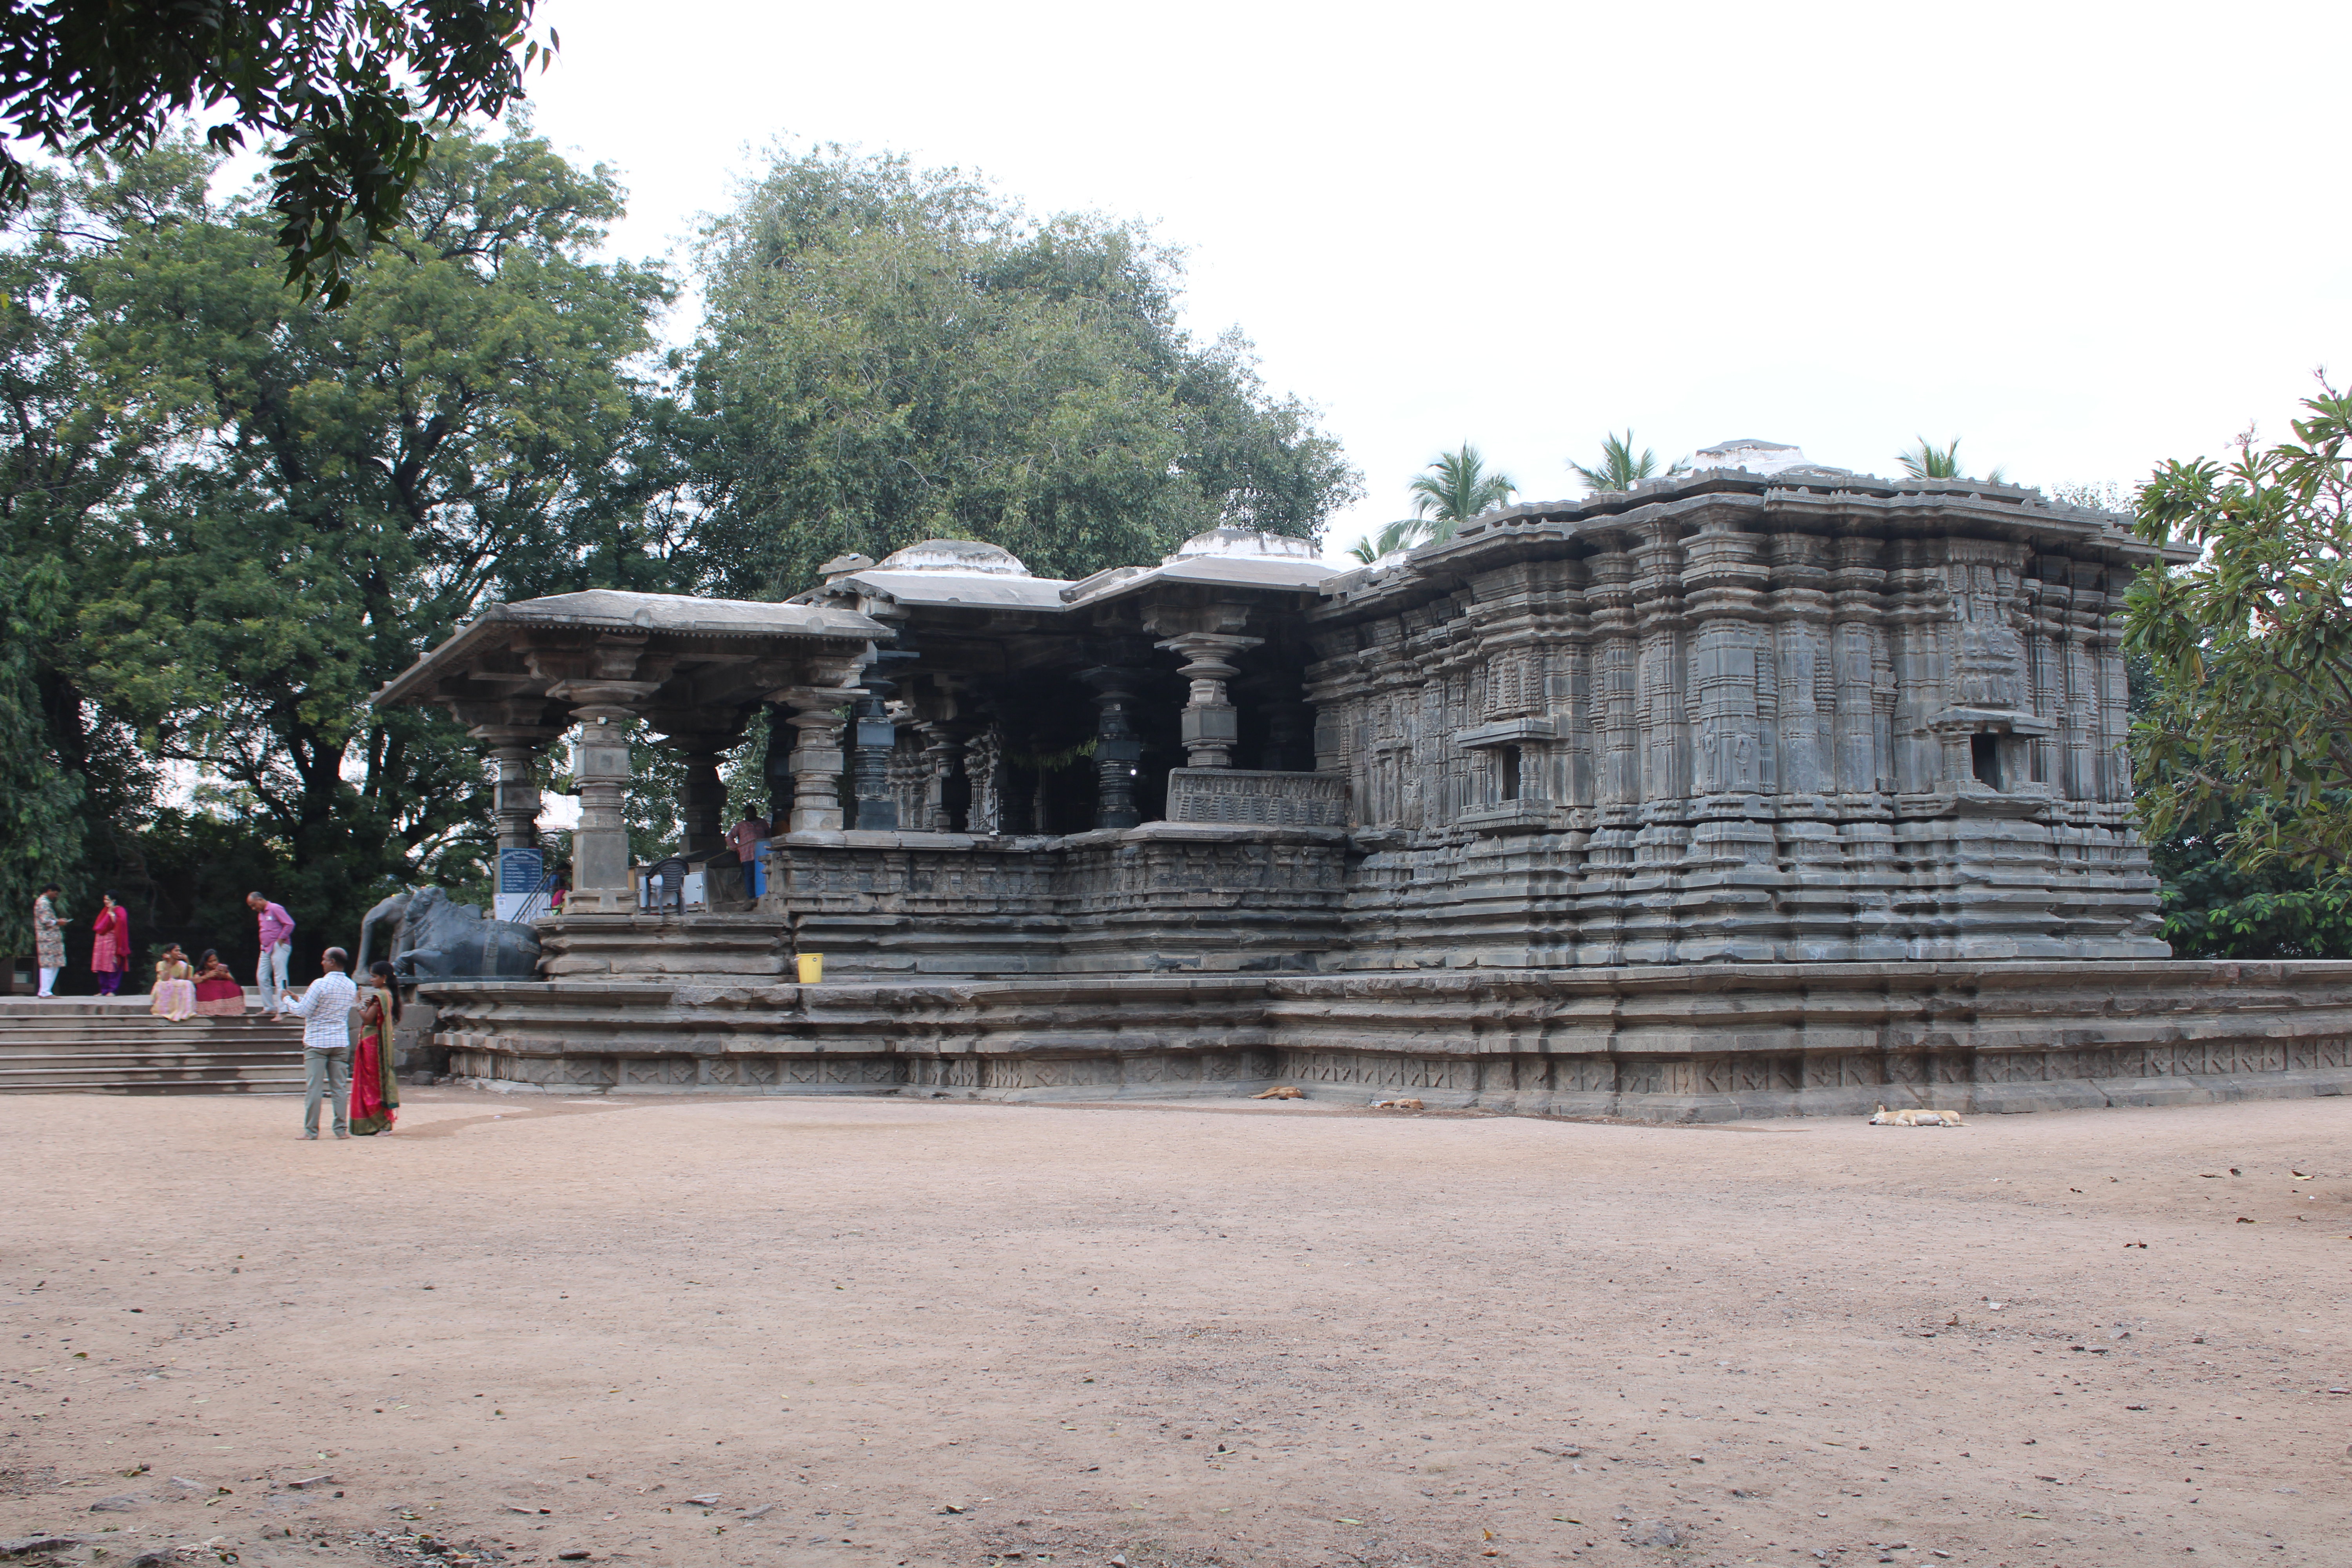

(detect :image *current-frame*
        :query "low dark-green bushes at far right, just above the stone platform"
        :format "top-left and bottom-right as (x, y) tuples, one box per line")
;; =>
(2152, 792), (2352, 959)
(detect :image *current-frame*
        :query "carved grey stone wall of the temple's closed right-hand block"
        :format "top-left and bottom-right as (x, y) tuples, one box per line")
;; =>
(1308, 479), (2166, 969)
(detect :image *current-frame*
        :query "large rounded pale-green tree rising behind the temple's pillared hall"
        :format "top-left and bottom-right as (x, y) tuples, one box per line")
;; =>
(691, 148), (1362, 592)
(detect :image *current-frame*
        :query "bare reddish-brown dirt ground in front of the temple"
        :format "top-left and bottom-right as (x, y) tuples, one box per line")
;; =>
(0, 1091), (2352, 1568)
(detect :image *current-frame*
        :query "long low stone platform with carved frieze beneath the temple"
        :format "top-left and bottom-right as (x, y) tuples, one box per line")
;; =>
(421, 959), (2352, 1122)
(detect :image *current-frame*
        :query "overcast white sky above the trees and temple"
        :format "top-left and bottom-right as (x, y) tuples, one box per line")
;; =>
(515, 0), (2352, 555)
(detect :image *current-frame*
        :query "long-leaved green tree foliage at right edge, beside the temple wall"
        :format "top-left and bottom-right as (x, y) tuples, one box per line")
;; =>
(2124, 383), (2352, 872)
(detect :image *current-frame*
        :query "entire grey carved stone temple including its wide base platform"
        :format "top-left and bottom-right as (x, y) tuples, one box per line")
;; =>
(379, 442), (2352, 1119)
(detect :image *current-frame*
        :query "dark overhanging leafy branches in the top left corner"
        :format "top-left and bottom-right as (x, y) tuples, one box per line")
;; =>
(0, 0), (557, 308)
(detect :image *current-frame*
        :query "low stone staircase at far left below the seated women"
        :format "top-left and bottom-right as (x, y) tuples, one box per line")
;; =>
(0, 992), (303, 1096)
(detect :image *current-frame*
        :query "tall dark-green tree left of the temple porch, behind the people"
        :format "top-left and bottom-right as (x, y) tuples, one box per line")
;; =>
(39, 129), (670, 945)
